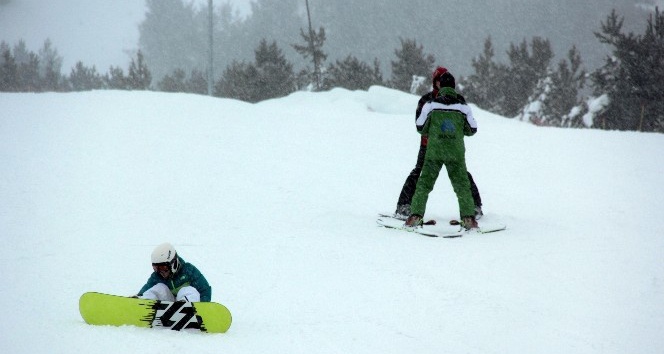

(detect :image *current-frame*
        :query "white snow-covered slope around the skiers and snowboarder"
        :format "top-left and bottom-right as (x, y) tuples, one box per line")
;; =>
(0, 87), (664, 354)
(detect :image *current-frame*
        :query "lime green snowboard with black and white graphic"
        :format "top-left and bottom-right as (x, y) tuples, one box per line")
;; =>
(78, 292), (232, 333)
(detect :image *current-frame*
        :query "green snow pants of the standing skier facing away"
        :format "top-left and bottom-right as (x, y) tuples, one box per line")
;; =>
(410, 158), (475, 219)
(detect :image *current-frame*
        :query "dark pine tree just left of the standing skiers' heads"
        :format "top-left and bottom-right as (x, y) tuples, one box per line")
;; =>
(389, 38), (435, 92)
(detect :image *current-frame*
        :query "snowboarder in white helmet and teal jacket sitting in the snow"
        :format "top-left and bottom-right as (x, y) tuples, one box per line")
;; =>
(135, 243), (212, 302)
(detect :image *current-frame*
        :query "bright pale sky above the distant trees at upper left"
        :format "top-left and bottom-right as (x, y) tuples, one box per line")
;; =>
(0, 0), (251, 74)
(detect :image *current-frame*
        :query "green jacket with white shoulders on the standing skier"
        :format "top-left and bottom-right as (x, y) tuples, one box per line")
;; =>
(415, 87), (477, 161)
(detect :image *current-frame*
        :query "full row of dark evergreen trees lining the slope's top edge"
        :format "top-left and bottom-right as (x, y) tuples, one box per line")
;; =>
(0, 9), (664, 132)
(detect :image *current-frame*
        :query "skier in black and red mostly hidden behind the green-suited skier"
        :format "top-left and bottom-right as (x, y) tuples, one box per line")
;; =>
(394, 66), (483, 220)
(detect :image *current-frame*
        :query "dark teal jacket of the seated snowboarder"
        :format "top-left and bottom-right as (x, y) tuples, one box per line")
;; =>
(138, 256), (212, 302)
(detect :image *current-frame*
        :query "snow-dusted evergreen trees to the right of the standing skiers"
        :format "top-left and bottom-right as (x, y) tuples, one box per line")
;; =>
(464, 9), (664, 133)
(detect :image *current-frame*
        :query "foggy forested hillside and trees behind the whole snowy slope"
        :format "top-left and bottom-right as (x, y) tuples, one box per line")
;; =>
(0, 0), (664, 132)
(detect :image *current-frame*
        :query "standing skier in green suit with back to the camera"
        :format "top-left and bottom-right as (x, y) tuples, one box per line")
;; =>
(406, 71), (478, 230)
